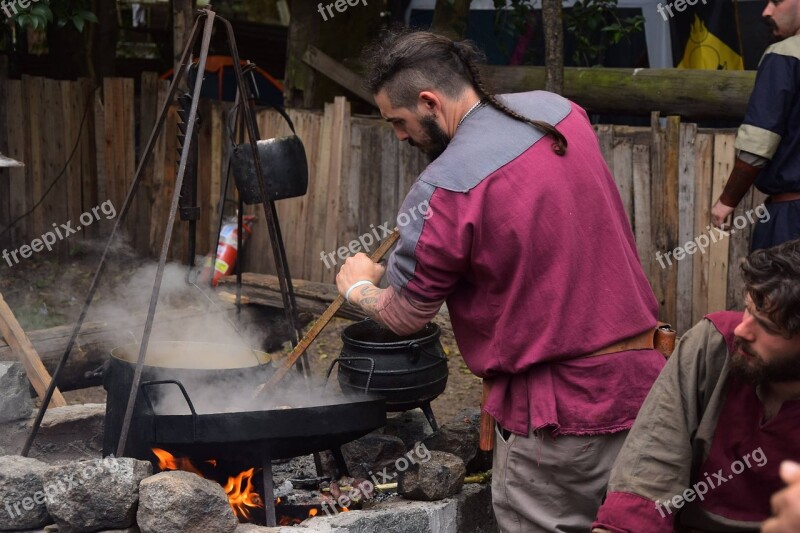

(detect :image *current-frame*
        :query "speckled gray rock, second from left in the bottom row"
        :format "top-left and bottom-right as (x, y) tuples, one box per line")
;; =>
(44, 457), (153, 533)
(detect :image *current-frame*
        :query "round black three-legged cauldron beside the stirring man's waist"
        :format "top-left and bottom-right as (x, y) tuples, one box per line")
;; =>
(329, 319), (448, 430)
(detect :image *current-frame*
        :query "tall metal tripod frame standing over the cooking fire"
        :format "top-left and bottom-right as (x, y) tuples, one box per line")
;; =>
(21, 9), (301, 478)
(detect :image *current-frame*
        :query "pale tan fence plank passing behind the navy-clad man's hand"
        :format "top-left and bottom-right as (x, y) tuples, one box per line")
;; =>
(708, 133), (736, 312)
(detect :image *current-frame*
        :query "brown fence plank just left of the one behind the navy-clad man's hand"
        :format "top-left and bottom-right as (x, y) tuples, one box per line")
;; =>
(692, 133), (714, 324)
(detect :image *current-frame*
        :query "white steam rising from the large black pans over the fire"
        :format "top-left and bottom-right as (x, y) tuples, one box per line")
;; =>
(89, 264), (342, 414)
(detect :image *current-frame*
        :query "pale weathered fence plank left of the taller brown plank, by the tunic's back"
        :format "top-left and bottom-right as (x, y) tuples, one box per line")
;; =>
(633, 144), (660, 279)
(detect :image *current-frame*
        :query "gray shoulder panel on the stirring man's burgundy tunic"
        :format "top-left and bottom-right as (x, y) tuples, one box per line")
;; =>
(419, 91), (572, 192)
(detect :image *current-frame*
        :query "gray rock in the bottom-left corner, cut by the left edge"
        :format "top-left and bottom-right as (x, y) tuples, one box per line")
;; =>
(0, 455), (50, 530)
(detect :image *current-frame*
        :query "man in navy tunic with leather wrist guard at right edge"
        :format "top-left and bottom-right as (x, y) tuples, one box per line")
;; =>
(711, 0), (800, 251)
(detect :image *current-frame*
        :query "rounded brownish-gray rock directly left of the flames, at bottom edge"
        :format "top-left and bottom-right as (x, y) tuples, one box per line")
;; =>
(136, 471), (238, 533)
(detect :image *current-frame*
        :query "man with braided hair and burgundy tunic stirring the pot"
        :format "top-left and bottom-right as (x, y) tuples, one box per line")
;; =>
(336, 32), (664, 533)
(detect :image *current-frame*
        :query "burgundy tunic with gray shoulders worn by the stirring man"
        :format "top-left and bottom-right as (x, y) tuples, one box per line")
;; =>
(388, 91), (664, 435)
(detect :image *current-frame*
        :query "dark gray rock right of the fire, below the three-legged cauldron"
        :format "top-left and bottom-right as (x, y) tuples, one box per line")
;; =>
(397, 451), (467, 501)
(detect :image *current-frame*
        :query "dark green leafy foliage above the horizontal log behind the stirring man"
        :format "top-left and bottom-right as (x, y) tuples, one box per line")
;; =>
(494, 0), (644, 67)
